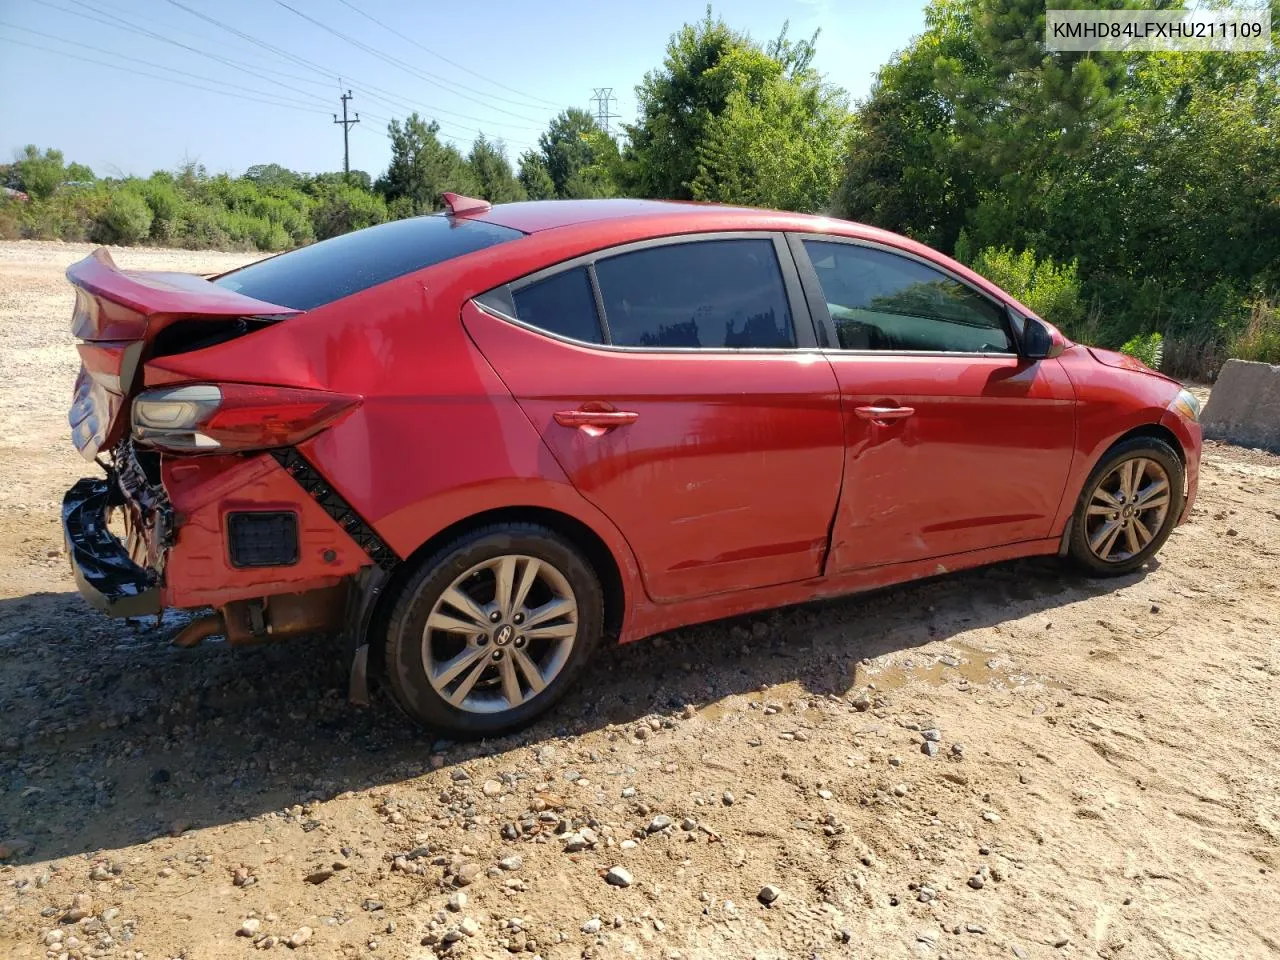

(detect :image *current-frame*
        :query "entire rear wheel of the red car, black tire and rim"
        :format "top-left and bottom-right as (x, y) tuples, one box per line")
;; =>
(384, 524), (604, 737)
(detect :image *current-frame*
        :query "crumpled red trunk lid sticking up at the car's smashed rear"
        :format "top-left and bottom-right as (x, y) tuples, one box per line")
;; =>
(67, 250), (300, 460)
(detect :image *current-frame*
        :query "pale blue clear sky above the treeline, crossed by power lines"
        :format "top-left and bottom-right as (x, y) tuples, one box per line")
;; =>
(0, 0), (924, 177)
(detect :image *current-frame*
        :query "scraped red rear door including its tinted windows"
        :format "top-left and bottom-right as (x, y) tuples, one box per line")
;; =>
(463, 233), (844, 600)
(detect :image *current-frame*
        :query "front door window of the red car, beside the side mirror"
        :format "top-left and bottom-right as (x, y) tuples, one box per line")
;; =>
(804, 241), (1015, 353)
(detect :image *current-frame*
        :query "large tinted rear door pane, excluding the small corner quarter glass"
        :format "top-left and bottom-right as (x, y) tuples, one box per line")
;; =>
(595, 239), (795, 348)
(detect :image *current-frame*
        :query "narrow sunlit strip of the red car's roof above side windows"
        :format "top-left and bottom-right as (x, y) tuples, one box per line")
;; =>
(481, 198), (873, 233)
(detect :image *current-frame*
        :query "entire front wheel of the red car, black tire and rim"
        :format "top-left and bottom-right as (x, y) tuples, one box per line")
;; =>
(1068, 436), (1184, 576)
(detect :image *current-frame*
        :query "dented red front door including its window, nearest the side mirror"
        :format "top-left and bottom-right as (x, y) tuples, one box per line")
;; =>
(792, 237), (1075, 573)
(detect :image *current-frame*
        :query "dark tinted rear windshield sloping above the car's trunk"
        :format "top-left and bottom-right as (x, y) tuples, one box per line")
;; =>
(214, 215), (524, 310)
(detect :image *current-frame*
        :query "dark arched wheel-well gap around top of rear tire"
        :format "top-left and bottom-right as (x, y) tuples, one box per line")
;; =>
(360, 506), (628, 673)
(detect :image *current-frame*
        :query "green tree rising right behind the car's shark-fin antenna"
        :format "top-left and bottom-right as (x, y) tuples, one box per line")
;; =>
(376, 113), (477, 215)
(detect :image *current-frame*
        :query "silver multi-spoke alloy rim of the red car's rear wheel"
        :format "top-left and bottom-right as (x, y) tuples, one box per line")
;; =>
(422, 554), (579, 713)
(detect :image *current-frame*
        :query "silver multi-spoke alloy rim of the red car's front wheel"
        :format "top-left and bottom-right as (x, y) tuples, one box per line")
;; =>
(1084, 457), (1170, 563)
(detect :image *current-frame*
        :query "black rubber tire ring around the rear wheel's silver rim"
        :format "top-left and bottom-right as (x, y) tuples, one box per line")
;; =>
(384, 524), (604, 737)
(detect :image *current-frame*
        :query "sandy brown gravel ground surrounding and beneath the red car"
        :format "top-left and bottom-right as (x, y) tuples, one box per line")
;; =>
(0, 243), (1280, 960)
